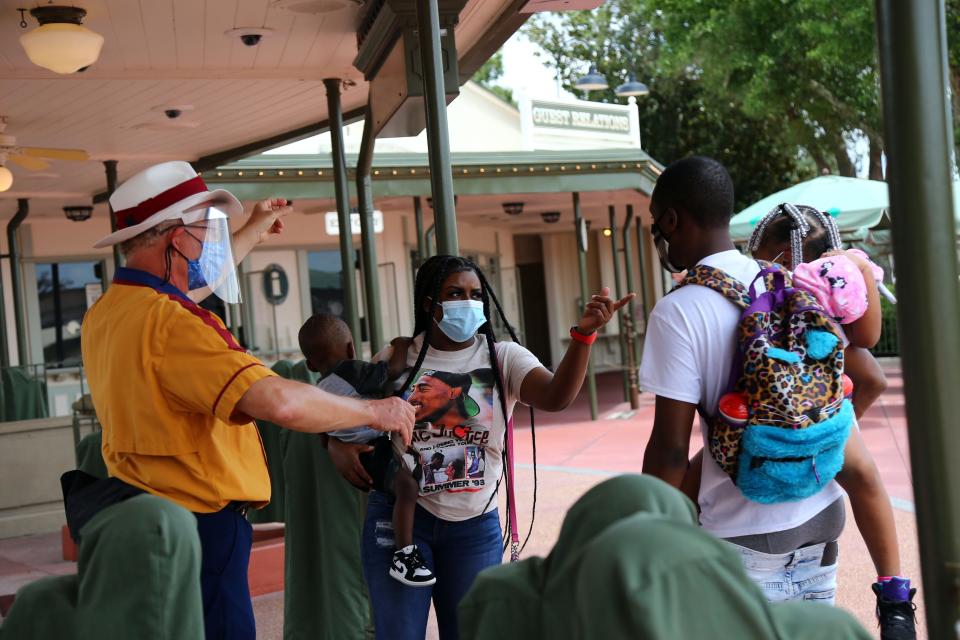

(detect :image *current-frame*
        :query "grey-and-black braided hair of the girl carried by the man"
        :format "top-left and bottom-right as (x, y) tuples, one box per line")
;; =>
(747, 202), (843, 271)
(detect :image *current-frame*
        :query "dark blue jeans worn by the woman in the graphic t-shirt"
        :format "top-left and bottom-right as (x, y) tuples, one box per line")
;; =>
(361, 491), (503, 640)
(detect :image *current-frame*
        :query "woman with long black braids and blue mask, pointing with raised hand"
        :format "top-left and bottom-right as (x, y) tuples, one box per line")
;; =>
(331, 256), (633, 640)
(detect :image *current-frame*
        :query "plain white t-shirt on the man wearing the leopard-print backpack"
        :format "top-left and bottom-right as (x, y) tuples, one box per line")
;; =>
(640, 250), (842, 538)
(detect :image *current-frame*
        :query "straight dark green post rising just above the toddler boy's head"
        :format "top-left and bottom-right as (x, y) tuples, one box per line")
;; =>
(323, 78), (363, 345)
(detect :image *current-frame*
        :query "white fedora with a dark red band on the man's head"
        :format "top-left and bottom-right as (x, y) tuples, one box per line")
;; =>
(93, 161), (243, 249)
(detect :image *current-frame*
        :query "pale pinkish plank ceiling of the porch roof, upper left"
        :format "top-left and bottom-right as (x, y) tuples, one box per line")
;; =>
(0, 0), (513, 217)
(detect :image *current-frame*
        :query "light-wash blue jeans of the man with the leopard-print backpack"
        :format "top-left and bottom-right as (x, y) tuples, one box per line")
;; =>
(728, 543), (838, 606)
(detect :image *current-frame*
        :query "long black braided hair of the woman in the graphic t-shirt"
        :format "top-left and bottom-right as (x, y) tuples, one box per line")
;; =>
(398, 255), (537, 551)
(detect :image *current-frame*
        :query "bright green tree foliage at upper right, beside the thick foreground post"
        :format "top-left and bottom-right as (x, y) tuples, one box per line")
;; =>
(660, 0), (883, 179)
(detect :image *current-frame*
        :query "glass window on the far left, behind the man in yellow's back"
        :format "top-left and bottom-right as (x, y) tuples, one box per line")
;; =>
(36, 262), (103, 367)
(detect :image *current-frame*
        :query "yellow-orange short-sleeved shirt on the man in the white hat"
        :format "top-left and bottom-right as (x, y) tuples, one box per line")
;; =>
(80, 268), (275, 513)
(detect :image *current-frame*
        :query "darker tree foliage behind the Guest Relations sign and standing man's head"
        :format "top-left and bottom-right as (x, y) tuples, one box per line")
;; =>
(526, 0), (816, 208)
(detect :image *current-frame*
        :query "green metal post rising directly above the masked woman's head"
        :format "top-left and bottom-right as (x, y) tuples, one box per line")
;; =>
(417, 0), (460, 256)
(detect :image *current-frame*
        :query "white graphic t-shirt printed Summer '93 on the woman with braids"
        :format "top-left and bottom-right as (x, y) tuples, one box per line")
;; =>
(374, 335), (543, 521)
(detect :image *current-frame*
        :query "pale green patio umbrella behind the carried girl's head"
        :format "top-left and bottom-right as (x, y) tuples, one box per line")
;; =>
(730, 176), (888, 242)
